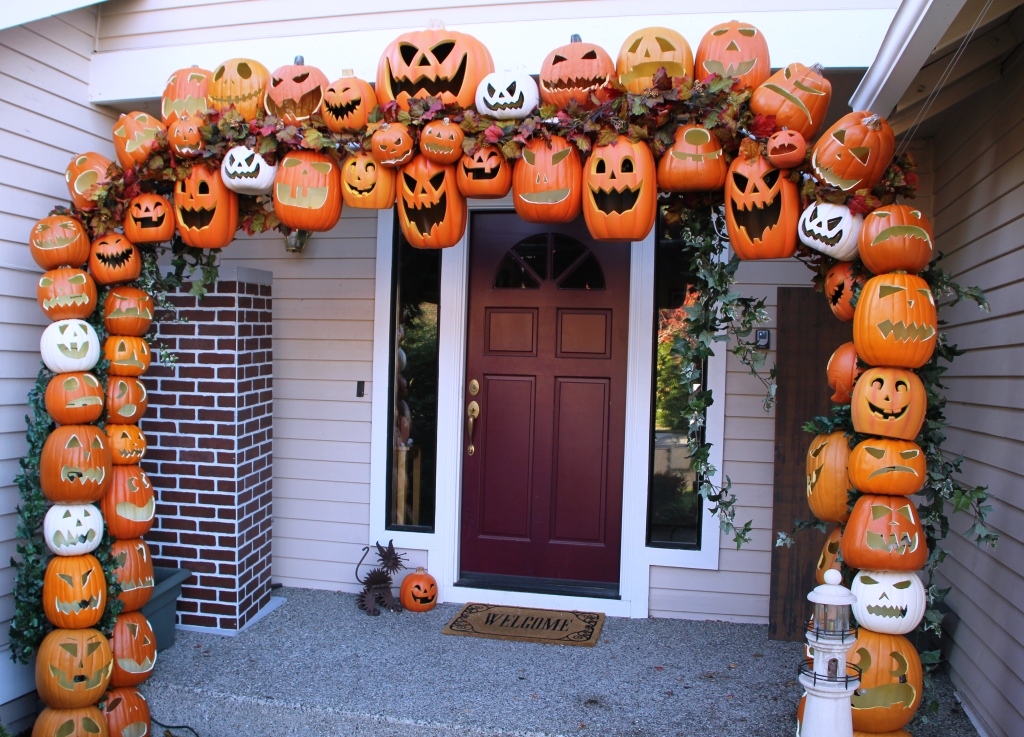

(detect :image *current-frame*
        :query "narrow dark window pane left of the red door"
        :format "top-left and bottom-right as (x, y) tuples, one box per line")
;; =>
(387, 228), (441, 532)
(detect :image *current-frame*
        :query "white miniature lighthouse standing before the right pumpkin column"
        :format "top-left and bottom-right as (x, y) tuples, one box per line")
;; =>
(800, 569), (860, 737)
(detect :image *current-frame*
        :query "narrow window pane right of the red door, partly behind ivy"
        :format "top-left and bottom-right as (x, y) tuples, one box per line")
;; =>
(647, 212), (706, 550)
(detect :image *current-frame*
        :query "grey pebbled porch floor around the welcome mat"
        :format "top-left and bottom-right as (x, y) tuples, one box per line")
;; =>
(142, 589), (977, 737)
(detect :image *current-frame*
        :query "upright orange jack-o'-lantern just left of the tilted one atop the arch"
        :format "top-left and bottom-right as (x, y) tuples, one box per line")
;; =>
(693, 20), (771, 89)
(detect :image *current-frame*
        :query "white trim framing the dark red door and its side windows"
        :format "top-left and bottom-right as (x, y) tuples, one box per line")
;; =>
(369, 197), (726, 617)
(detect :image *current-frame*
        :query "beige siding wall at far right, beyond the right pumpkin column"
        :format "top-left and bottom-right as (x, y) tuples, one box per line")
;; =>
(934, 56), (1024, 737)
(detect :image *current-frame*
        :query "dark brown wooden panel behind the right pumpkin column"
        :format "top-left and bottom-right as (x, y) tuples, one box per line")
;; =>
(768, 287), (852, 641)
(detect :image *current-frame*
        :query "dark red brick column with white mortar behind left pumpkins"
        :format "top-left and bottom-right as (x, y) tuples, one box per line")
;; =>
(139, 267), (273, 631)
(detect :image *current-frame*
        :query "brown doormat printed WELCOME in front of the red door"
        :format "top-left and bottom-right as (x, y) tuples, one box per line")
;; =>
(441, 604), (604, 647)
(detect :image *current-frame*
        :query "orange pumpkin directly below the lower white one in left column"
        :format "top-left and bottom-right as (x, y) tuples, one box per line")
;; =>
(43, 552), (106, 630)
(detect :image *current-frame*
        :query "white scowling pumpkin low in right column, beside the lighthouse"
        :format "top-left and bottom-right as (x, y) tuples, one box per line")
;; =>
(850, 570), (925, 635)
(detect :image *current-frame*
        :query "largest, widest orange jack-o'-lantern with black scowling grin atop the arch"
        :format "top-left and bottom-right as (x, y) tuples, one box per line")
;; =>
(377, 24), (495, 110)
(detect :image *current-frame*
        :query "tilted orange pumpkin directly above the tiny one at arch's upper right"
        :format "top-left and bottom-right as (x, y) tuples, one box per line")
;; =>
(751, 63), (831, 140)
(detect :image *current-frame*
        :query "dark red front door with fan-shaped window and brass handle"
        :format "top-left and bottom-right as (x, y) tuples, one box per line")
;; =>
(460, 213), (630, 588)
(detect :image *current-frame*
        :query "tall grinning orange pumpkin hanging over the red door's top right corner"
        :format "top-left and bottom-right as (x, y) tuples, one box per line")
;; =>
(583, 135), (657, 241)
